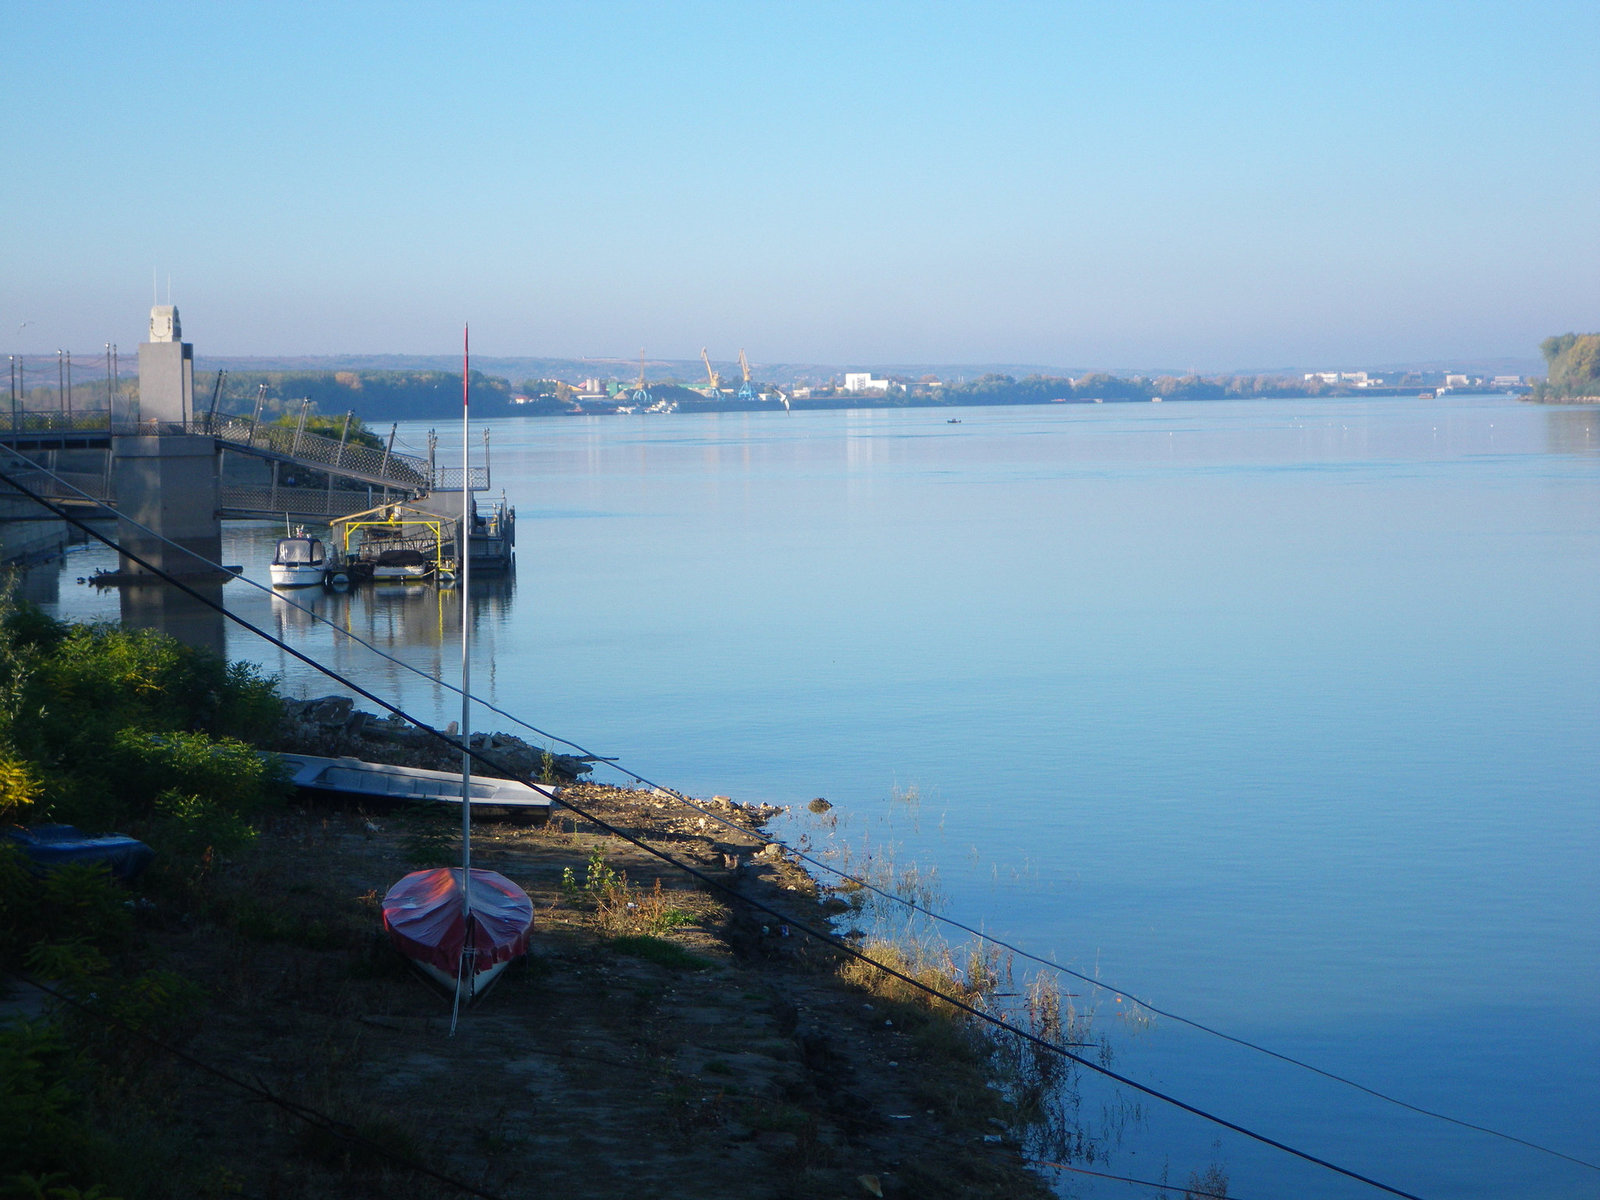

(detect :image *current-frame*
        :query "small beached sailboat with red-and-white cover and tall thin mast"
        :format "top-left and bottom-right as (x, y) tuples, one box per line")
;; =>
(382, 330), (533, 1011)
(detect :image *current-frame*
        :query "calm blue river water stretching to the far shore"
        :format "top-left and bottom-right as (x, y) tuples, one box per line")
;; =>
(34, 398), (1600, 1197)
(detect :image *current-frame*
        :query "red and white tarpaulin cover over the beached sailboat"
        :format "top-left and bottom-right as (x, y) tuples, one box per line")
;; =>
(384, 867), (533, 974)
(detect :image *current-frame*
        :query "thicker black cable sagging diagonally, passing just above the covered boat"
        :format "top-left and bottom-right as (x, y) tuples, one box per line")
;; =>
(0, 472), (1422, 1200)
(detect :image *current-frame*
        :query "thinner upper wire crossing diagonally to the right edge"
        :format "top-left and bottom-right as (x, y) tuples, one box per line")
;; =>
(13, 451), (1600, 1171)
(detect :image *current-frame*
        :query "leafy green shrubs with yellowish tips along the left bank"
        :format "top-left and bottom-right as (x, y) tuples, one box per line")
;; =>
(0, 589), (286, 1200)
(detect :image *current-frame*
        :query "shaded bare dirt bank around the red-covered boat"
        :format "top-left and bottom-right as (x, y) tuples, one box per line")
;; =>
(147, 786), (1051, 1200)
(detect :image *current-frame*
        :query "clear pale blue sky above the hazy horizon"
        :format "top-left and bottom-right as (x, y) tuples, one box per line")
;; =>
(0, 0), (1600, 371)
